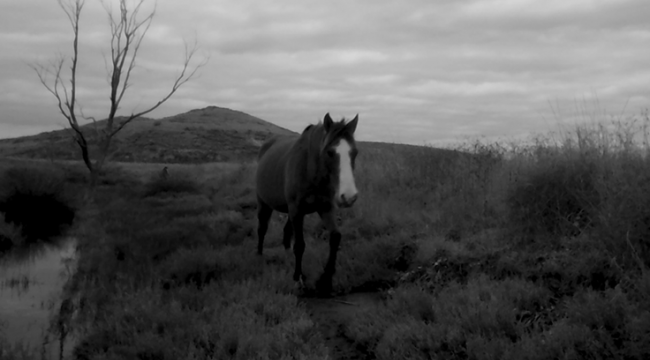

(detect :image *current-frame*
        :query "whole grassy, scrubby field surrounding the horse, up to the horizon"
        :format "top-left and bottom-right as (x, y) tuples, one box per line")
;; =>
(0, 117), (650, 359)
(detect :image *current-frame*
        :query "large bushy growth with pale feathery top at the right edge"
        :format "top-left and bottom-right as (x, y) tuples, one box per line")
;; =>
(506, 113), (650, 272)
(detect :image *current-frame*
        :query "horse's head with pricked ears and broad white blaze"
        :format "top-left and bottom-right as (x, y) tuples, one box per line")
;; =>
(320, 113), (359, 207)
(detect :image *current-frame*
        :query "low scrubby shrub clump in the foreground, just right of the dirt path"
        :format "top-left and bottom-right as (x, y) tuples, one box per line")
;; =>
(346, 276), (551, 359)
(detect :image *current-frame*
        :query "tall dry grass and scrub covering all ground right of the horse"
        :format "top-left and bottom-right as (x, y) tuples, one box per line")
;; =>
(345, 114), (650, 359)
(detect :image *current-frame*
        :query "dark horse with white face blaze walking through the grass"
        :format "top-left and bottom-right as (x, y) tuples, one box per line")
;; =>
(256, 113), (359, 292)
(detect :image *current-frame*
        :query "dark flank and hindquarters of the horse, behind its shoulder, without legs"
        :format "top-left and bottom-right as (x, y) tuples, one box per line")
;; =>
(255, 136), (298, 212)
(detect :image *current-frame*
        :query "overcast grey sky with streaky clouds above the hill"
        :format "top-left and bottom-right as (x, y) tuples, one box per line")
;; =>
(0, 0), (650, 144)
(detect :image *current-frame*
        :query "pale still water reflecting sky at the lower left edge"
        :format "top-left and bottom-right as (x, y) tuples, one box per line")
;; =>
(0, 239), (76, 352)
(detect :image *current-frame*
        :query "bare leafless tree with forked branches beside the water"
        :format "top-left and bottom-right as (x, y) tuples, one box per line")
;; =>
(30, 0), (207, 184)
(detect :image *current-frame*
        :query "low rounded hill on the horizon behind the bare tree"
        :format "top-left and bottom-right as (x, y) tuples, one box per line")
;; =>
(0, 106), (295, 163)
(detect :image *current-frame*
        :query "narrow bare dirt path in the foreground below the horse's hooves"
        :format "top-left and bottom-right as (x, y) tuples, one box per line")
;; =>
(301, 292), (382, 360)
